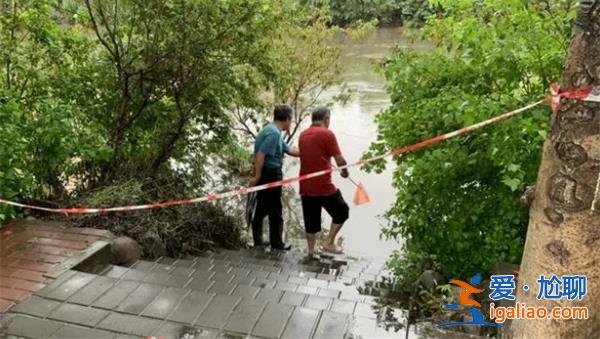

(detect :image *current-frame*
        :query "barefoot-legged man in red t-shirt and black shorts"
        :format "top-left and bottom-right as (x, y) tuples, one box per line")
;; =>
(299, 107), (350, 257)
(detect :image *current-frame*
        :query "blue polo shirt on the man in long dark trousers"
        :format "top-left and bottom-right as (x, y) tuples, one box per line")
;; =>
(254, 123), (290, 168)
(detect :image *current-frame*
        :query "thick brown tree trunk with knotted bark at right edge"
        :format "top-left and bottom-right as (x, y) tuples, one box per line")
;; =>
(512, 0), (600, 338)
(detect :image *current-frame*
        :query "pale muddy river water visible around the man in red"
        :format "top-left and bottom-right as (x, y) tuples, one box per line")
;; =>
(286, 28), (427, 258)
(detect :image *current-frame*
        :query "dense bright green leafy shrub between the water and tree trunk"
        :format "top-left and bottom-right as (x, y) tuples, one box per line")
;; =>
(372, 0), (574, 284)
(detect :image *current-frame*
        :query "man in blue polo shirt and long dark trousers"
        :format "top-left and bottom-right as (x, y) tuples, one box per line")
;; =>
(250, 105), (300, 251)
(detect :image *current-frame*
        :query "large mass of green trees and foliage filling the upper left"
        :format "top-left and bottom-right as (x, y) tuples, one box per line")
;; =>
(0, 0), (307, 230)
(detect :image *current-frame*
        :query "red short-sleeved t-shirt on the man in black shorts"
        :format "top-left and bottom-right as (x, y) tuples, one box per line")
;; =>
(299, 125), (342, 196)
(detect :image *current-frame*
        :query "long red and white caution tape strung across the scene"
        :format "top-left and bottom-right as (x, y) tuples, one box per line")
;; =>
(0, 85), (600, 214)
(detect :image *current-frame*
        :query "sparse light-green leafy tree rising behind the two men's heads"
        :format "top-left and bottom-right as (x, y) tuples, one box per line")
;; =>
(232, 1), (373, 142)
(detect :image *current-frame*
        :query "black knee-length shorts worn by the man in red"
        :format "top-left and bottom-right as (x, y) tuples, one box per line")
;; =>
(302, 190), (350, 234)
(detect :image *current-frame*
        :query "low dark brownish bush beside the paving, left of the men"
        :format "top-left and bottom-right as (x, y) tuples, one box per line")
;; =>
(61, 180), (245, 258)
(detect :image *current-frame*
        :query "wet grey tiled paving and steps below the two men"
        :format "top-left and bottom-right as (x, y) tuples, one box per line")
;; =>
(0, 250), (403, 339)
